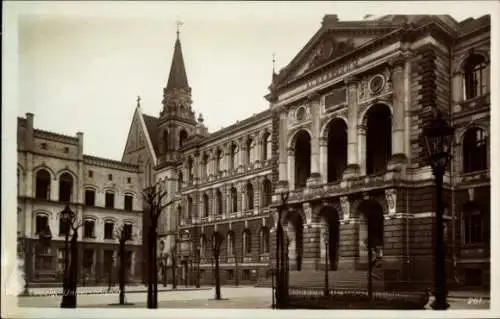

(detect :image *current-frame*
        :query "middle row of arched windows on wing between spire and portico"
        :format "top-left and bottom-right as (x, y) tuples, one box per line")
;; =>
(178, 178), (273, 219)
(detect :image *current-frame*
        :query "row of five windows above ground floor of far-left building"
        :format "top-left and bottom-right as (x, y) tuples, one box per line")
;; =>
(35, 215), (132, 239)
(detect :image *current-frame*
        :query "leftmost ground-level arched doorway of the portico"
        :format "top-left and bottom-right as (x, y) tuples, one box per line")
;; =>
(284, 211), (304, 271)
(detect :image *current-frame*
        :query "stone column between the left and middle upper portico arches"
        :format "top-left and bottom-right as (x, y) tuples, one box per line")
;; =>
(308, 93), (321, 183)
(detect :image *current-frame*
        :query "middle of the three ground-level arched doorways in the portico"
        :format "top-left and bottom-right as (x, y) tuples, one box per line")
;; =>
(319, 206), (340, 270)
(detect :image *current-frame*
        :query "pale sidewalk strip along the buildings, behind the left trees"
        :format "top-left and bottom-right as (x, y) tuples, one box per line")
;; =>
(21, 284), (212, 296)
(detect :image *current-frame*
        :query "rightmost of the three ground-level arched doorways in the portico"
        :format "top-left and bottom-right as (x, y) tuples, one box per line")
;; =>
(358, 199), (384, 267)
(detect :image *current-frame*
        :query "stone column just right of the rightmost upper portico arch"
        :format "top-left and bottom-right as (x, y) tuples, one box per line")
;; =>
(391, 57), (405, 163)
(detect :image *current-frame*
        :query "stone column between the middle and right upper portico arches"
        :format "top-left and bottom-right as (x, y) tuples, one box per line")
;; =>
(344, 76), (360, 177)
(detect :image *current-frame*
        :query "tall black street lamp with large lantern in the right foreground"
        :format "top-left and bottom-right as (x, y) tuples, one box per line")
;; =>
(423, 108), (455, 310)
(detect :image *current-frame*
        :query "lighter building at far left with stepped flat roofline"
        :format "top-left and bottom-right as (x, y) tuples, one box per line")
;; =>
(17, 113), (143, 286)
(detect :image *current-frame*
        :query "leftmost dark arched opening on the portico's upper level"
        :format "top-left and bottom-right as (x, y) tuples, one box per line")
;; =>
(294, 130), (311, 188)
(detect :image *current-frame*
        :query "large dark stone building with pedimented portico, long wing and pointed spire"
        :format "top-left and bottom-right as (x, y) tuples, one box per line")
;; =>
(123, 15), (490, 286)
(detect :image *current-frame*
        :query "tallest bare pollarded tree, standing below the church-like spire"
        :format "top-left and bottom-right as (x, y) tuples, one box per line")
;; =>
(143, 182), (177, 308)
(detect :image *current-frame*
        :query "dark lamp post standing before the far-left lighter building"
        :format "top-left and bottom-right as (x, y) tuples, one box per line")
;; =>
(60, 205), (76, 308)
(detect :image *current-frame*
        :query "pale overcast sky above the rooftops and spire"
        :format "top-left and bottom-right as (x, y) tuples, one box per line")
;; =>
(7, 1), (491, 160)
